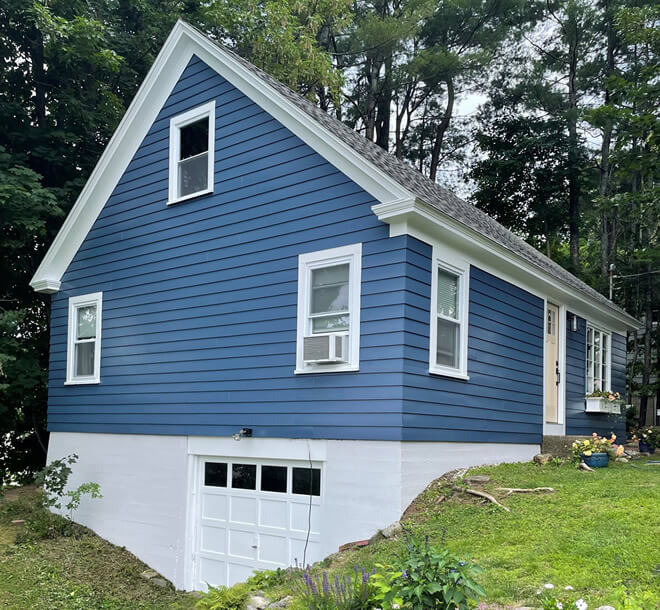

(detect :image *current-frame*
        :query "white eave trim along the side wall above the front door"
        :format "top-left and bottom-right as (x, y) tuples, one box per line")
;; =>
(371, 199), (639, 334)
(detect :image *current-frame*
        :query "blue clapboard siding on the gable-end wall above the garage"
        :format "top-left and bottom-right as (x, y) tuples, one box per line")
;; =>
(49, 58), (409, 440)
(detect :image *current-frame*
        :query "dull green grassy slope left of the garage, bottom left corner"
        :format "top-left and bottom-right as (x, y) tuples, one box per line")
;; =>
(0, 488), (196, 610)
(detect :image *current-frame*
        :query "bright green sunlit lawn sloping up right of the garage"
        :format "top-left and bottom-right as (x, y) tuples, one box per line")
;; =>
(260, 460), (660, 610)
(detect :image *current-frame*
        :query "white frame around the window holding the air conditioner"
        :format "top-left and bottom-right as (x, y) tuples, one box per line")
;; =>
(295, 243), (362, 374)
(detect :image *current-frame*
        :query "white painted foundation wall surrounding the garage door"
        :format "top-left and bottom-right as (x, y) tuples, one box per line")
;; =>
(48, 432), (539, 589)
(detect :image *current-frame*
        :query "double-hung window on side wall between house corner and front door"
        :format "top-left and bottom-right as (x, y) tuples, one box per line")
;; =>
(429, 262), (467, 378)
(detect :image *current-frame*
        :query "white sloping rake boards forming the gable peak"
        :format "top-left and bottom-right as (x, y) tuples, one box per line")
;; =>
(30, 21), (412, 293)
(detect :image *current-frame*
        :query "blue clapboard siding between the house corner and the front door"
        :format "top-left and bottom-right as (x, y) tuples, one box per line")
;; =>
(403, 239), (543, 443)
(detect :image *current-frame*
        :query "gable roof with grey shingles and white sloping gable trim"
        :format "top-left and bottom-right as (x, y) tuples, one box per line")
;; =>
(30, 21), (638, 328)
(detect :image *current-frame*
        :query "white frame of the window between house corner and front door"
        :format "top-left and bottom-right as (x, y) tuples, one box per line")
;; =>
(429, 256), (470, 380)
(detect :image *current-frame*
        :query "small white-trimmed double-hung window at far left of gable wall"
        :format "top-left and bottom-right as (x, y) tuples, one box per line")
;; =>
(66, 292), (102, 384)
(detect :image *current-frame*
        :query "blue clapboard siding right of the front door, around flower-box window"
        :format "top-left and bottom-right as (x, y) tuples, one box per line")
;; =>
(566, 313), (626, 439)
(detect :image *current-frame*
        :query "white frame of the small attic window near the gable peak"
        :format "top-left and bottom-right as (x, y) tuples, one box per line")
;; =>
(167, 100), (215, 205)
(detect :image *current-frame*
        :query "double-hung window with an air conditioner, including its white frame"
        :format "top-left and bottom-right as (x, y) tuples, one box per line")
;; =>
(296, 244), (362, 373)
